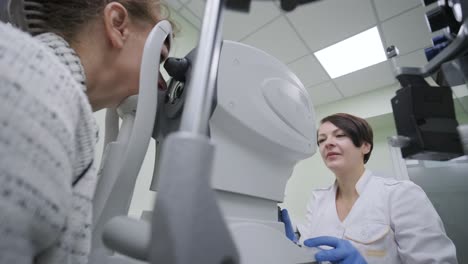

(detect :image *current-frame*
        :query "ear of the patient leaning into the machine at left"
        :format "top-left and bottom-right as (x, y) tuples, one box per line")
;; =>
(104, 2), (130, 48)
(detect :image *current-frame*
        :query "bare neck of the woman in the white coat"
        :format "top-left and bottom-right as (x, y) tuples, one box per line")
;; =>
(335, 166), (365, 200)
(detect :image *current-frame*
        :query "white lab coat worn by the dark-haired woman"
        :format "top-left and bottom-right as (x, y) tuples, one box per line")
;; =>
(298, 170), (457, 264)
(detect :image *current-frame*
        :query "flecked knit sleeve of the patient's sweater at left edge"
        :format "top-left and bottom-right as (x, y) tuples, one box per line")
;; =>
(0, 23), (85, 264)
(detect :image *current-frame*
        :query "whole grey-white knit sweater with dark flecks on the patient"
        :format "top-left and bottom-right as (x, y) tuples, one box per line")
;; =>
(0, 23), (97, 264)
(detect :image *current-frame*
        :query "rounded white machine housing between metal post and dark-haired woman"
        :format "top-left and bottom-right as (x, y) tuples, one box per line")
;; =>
(209, 41), (316, 264)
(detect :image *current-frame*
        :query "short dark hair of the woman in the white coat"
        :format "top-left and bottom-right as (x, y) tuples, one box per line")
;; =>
(320, 113), (374, 164)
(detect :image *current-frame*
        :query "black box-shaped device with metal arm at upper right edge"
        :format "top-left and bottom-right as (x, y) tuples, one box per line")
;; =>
(389, 0), (468, 160)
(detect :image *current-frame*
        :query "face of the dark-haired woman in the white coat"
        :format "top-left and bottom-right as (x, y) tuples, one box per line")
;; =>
(317, 122), (369, 172)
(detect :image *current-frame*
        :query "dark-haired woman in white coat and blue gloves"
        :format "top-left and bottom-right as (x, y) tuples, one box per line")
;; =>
(282, 113), (457, 264)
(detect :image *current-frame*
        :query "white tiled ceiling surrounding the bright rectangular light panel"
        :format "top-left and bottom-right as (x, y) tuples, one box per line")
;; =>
(166, 0), (431, 105)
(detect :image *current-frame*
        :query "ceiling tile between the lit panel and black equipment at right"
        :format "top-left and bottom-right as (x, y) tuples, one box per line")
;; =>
(382, 7), (431, 55)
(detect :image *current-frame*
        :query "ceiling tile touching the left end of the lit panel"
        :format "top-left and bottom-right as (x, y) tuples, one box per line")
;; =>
(288, 55), (330, 87)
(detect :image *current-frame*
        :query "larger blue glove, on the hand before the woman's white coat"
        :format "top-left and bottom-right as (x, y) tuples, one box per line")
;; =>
(304, 236), (367, 264)
